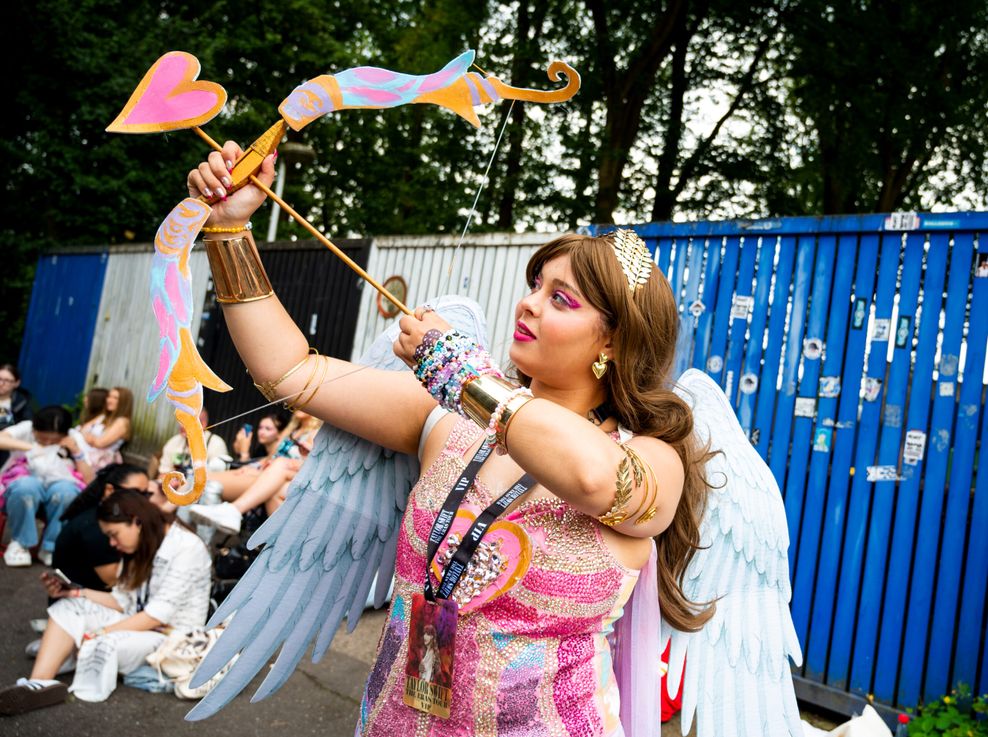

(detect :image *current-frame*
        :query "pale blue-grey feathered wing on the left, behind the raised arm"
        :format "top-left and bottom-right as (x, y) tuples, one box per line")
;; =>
(186, 296), (487, 721)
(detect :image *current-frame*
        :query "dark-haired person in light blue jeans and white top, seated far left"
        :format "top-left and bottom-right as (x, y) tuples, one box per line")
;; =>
(0, 405), (94, 568)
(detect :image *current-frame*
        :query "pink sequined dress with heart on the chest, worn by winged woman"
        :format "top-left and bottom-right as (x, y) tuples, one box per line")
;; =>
(357, 420), (638, 737)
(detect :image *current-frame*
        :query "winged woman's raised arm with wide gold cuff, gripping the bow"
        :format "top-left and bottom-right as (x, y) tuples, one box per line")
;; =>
(187, 141), (435, 453)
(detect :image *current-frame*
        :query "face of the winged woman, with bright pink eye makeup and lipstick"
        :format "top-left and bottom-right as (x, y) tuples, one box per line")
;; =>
(509, 254), (610, 388)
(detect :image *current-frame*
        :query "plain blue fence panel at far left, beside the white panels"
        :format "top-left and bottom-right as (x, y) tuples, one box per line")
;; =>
(18, 251), (107, 405)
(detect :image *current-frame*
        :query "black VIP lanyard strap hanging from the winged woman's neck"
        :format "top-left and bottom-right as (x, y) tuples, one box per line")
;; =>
(425, 443), (535, 601)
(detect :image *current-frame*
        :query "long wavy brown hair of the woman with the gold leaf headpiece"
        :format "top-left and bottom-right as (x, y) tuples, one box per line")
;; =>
(527, 235), (714, 632)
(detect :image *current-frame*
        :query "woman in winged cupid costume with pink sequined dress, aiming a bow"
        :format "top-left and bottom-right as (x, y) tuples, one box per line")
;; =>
(188, 143), (801, 737)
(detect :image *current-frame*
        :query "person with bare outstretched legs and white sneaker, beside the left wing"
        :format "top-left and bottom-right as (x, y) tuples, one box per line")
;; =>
(189, 410), (322, 535)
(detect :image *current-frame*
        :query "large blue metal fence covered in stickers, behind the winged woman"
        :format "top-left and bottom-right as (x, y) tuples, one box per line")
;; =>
(599, 213), (988, 708)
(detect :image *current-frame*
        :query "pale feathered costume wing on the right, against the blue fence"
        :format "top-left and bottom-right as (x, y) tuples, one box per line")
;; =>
(662, 369), (803, 737)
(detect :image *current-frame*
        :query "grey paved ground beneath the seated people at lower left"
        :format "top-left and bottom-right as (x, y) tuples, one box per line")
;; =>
(0, 564), (836, 737)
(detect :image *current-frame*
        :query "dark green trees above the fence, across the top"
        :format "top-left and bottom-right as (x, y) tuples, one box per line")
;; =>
(0, 0), (988, 358)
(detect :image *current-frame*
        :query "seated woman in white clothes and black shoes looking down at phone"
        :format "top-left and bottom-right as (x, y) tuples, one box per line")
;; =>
(0, 489), (210, 715)
